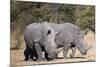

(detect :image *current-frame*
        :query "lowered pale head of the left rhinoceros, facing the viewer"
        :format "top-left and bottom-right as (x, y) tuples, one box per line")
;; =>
(43, 22), (60, 58)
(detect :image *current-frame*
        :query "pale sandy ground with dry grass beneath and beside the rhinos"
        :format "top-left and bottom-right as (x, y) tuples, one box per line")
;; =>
(10, 32), (95, 67)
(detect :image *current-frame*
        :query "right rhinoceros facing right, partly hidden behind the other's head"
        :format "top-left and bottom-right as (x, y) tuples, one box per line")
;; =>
(49, 23), (92, 58)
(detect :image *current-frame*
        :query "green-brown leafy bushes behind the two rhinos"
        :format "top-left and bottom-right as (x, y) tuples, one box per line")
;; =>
(11, 1), (95, 49)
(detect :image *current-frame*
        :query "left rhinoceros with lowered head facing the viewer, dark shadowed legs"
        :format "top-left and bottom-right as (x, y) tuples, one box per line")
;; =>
(24, 22), (61, 61)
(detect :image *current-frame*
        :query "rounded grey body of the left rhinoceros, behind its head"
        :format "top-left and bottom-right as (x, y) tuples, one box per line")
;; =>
(24, 23), (42, 48)
